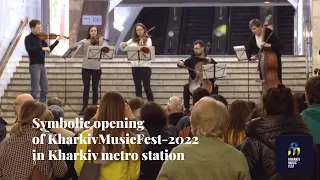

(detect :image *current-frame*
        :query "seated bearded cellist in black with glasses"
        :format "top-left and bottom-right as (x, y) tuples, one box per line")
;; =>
(177, 40), (218, 114)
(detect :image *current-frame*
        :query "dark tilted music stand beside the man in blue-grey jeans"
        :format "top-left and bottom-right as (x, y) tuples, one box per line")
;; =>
(61, 43), (82, 112)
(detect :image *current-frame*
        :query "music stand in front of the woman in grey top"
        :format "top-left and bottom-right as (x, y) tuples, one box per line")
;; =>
(87, 46), (114, 100)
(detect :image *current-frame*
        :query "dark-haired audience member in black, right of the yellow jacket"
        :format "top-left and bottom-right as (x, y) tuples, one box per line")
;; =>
(139, 102), (178, 180)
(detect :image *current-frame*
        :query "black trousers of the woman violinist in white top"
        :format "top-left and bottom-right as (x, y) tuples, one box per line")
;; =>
(132, 67), (154, 101)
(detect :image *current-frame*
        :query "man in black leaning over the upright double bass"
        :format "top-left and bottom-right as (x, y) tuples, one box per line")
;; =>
(246, 19), (283, 83)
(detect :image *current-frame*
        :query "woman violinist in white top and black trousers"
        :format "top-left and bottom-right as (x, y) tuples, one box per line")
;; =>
(120, 23), (154, 101)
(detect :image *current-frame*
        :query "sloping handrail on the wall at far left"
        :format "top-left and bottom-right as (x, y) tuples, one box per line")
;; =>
(0, 16), (28, 77)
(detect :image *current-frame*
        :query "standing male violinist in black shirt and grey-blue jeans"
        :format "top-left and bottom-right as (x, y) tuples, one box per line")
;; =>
(24, 19), (60, 103)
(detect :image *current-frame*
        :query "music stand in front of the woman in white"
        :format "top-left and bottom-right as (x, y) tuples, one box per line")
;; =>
(126, 46), (155, 61)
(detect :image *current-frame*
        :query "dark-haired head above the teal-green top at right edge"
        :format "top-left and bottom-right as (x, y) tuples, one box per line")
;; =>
(305, 76), (320, 105)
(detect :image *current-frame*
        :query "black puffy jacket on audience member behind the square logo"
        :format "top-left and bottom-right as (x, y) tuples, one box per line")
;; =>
(241, 114), (319, 180)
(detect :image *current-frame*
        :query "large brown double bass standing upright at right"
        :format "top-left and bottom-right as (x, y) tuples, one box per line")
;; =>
(258, 14), (280, 92)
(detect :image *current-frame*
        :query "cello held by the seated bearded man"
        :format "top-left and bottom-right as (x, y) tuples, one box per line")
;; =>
(189, 43), (215, 94)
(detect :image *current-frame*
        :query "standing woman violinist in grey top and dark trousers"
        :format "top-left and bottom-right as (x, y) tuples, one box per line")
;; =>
(79, 26), (103, 115)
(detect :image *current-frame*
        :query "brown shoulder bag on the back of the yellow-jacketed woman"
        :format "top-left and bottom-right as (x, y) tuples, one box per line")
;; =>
(79, 145), (101, 180)
